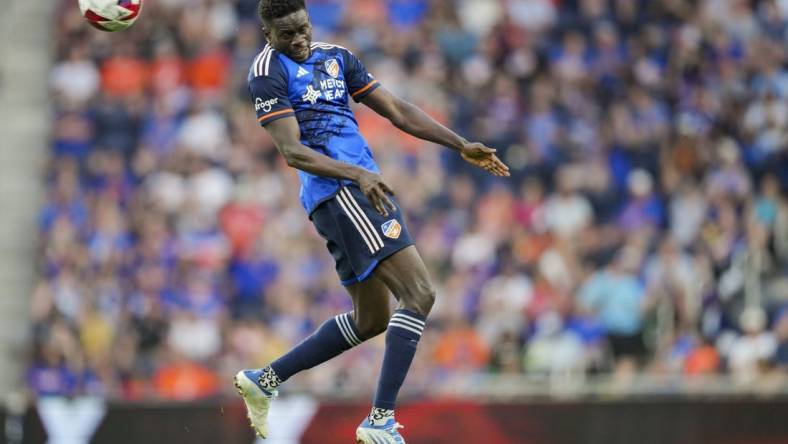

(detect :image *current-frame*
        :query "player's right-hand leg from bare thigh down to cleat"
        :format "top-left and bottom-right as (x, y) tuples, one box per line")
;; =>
(356, 246), (435, 444)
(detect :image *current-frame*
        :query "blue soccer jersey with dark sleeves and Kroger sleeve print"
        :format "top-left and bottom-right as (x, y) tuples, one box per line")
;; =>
(248, 42), (380, 213)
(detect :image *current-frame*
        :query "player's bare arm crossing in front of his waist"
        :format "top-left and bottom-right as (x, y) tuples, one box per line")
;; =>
(265, 117), (396, 216)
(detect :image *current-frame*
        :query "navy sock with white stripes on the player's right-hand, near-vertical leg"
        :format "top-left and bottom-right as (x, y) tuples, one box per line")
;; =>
(373, 309), (427, 410)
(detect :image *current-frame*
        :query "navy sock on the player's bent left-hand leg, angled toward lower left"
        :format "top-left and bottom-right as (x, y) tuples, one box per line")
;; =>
(271, 313), (362, 385)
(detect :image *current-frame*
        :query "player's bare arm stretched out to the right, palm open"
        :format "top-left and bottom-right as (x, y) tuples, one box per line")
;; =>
(361, 87), (509, 176)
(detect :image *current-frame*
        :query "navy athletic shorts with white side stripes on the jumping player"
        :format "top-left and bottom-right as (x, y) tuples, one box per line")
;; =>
(309, 185), (413, 285)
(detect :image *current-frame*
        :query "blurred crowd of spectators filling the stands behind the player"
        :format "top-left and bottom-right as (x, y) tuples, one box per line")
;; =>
(28, 0), (788, 400)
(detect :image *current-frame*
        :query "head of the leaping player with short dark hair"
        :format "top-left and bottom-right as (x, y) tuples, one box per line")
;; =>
(257, 0), (312, 62)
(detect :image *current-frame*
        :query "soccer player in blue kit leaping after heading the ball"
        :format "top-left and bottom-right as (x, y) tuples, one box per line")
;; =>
(235, 0), (509, 443)
